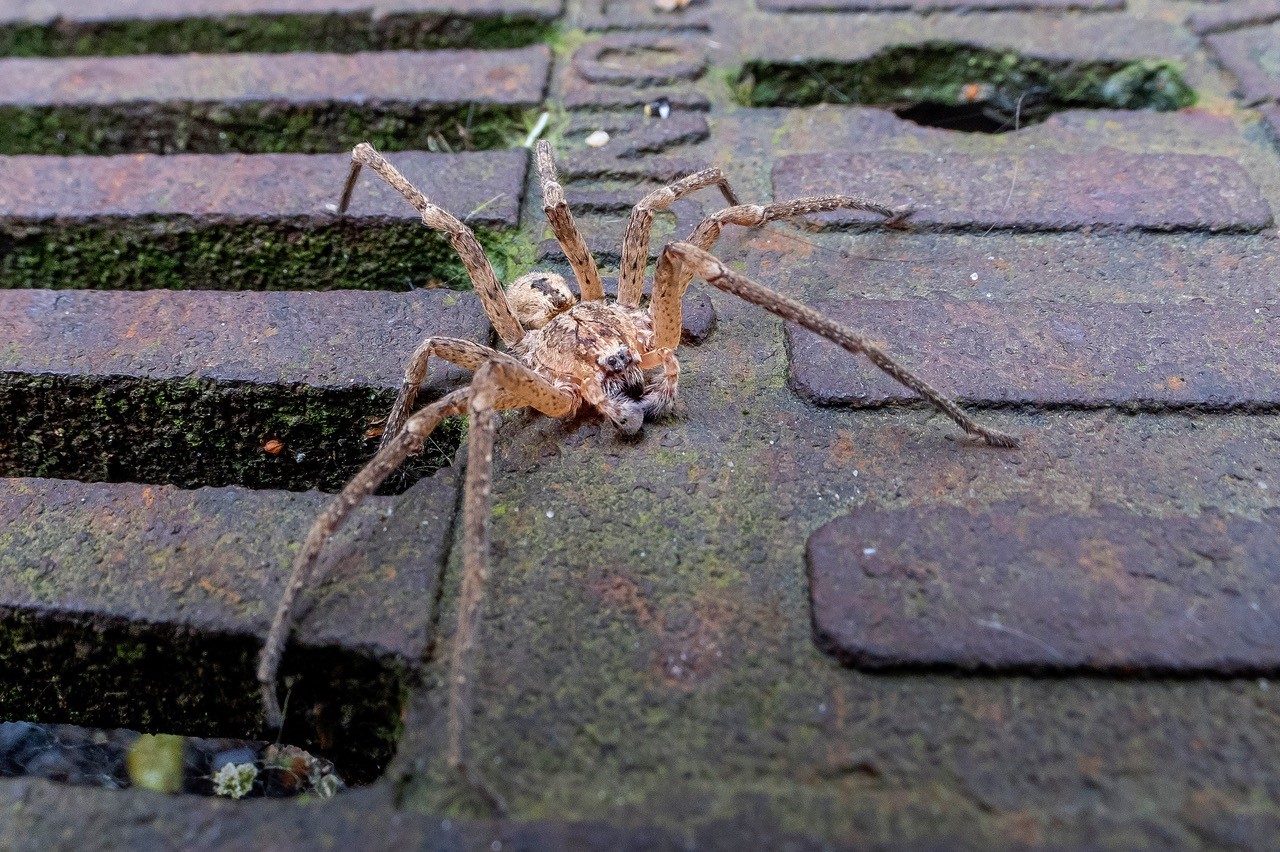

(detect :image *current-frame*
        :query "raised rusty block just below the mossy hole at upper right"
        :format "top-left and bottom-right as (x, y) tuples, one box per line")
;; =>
(773, 150), (1272, 232)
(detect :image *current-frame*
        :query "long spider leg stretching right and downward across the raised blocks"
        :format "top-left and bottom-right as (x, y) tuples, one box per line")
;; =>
(650, 242), (1018, 446)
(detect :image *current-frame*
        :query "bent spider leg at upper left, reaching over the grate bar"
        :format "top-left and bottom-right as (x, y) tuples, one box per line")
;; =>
(338, 142), (525, 347)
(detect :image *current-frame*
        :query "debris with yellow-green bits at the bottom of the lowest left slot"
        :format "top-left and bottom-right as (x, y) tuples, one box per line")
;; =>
(0, 722), (343, 798)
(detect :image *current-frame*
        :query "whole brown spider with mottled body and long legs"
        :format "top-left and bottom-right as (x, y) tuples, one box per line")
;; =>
(257, 142), (1018, 810)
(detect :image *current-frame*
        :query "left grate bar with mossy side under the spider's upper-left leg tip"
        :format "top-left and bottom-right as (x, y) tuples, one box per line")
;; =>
(0, 150), (529, 289)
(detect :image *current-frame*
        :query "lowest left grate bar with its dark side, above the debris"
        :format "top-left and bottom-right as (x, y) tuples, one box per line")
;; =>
(0, 472), (457, 783)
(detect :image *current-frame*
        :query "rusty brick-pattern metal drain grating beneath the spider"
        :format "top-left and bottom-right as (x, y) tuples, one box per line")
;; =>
(0, 0), (1280, 849)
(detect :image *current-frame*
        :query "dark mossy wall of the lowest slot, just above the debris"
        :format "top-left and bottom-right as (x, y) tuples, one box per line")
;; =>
(0, 610), (408, 784)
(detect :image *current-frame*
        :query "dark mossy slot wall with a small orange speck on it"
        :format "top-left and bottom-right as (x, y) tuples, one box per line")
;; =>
(0, 374), (462, 491)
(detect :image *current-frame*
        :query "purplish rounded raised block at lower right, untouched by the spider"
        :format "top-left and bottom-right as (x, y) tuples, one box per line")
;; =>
(808, 503), (1280, 673)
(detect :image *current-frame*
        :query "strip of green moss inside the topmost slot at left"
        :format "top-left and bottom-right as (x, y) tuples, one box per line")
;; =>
(0, 13), (554, 56)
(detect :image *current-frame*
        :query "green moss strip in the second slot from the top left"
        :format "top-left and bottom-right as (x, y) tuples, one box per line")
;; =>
(0, 101), (527, 156)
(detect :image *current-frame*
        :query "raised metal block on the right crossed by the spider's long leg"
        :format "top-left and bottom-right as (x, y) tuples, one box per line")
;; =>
(787, 298), (1280, 409)
